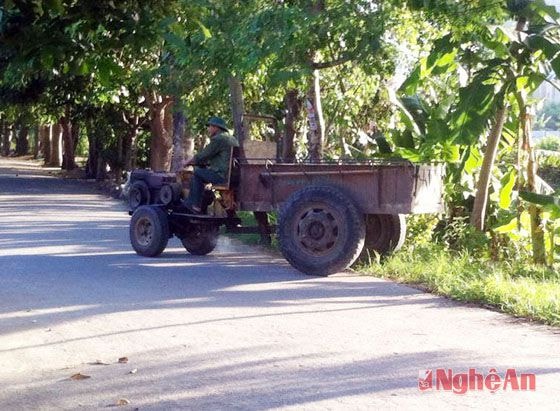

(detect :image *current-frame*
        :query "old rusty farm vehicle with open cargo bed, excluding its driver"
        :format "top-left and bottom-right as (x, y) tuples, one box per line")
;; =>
(130, 142), (444, 275)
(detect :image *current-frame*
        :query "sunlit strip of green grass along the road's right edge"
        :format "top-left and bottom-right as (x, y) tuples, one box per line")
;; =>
(355, 244), (560, 326)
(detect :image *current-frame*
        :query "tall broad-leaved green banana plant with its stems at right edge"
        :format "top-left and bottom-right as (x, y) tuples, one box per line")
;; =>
(396, 0), (560, 263)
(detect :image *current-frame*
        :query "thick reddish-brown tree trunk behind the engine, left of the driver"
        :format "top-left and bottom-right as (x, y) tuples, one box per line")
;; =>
(150, 96), (173, 171)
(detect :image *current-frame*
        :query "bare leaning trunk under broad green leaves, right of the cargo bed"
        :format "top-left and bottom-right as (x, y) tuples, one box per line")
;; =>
(471, 106), (508, 231)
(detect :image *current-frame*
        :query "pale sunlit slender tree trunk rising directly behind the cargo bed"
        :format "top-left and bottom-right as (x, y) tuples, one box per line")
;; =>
(305, 70), (325, 163)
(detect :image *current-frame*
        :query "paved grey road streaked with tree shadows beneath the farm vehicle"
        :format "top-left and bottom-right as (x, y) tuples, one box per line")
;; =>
(0, 160), (560, 410)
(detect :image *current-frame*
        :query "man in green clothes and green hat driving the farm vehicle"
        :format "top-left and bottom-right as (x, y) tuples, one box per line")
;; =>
(184, 117), (239, 214)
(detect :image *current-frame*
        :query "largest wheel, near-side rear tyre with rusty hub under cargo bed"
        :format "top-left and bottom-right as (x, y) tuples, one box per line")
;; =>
(278, 186), (365, 275)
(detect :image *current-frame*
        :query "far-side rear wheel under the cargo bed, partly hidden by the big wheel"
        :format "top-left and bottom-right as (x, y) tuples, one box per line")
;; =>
(365, 214), (406, 254)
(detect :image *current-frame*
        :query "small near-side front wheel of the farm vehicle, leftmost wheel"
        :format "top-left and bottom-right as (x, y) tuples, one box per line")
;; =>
(129, 206), (169, 257)
